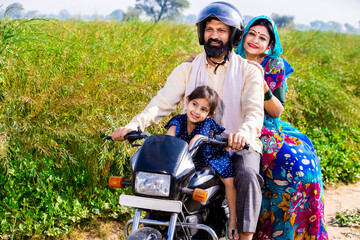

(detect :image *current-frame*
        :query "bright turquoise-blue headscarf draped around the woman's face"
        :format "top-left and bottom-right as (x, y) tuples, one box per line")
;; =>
(235, 15), (283, 58)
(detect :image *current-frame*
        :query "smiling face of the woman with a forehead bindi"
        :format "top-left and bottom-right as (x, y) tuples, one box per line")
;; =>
(244, 25), (270, 58)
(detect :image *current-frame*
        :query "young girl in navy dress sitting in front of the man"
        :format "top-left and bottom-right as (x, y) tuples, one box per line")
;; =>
(165, 86), (239, 239)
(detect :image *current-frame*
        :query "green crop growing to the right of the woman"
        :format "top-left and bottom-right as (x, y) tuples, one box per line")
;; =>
(281, 31), (360, 183)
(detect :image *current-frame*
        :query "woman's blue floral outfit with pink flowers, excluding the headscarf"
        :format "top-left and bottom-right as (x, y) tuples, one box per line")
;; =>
(257, 57), (328, 240)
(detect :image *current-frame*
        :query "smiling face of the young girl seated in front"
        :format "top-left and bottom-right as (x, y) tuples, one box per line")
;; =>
(186, 98), (211, 124)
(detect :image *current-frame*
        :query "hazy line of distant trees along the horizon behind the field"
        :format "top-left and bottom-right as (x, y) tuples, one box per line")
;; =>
(0, 0), (360, 34)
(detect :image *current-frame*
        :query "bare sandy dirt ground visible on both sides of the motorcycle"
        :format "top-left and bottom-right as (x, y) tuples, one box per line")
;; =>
(67, 182), (360, 240)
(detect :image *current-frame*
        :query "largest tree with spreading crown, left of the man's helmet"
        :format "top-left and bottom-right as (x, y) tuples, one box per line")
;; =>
(135, 0), (189, 23)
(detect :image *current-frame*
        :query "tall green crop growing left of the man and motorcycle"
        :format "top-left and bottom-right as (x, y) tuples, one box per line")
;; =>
(0, 21), (195, 238)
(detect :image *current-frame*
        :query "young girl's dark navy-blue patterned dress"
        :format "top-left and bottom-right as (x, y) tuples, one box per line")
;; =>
(165, 114), (234, 178)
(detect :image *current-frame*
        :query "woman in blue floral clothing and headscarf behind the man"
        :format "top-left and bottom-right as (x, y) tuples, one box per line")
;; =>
(235, 16), (328, 239)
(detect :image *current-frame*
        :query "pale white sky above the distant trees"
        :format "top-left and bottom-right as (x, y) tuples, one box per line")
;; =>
(0, 0), (360, 27)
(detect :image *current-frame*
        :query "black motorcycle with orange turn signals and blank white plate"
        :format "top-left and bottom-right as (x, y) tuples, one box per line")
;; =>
(108, 131), (249, 240)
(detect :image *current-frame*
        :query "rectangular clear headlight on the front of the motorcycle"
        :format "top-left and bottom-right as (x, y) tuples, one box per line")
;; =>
(135, 172), (171, 197)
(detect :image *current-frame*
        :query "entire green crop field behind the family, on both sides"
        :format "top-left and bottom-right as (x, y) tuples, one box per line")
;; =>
(0, 16), (360, 239)
